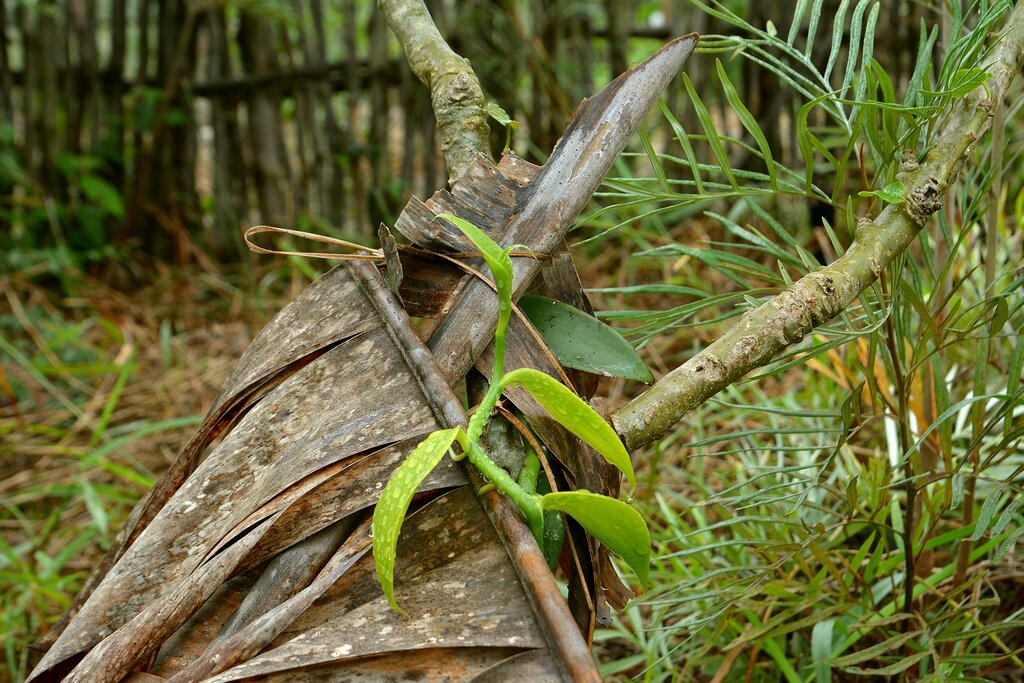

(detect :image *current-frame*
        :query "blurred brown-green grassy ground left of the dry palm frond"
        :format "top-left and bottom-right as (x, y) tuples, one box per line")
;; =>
(0, 260), (311, 680)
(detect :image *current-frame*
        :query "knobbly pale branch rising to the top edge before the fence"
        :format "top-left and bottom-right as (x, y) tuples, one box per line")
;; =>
(377, 0), (490, 184)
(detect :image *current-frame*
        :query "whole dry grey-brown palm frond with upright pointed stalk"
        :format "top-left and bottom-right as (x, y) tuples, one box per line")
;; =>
(31, 37), (695, 681)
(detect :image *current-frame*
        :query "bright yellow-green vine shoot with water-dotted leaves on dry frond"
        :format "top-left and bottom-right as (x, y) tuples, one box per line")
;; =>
(373, 214), (650, 614)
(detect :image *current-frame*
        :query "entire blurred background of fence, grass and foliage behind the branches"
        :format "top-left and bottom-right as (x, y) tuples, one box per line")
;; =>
(0, 0), (1024, 681)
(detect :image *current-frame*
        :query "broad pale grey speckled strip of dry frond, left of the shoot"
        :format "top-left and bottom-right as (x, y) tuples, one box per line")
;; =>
(48, 331), (434, 656)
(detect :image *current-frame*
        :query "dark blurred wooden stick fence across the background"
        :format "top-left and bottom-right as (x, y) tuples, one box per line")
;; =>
(0, 0), (929, 259)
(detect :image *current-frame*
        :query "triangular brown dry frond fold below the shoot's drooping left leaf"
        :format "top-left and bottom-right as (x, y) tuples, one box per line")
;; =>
(192, 487), (545, 682)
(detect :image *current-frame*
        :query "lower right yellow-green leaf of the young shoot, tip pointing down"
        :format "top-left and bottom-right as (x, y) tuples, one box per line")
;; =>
(541, 490), (650, 590)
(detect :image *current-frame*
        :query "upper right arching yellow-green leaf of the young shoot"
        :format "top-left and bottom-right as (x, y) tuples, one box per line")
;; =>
(501, 368), (636, 487)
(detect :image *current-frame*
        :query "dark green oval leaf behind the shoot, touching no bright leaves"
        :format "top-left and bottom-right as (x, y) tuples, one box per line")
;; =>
(519, 294), (654, 382)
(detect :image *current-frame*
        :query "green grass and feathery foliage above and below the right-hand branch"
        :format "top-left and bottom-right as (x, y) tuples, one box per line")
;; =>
(591, 3), (1024, 683)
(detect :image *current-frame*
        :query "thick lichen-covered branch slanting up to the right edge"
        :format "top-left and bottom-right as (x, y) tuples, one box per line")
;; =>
(611, 2), (1024, 450)
